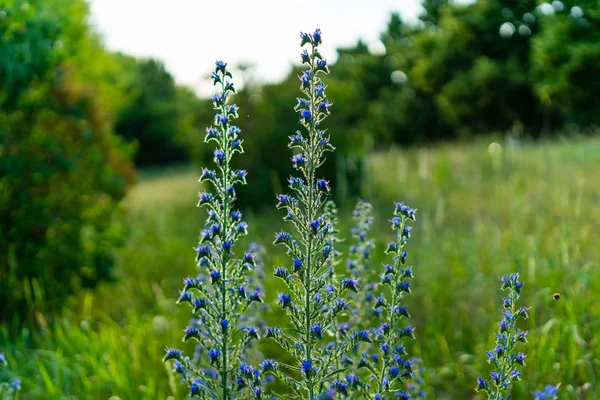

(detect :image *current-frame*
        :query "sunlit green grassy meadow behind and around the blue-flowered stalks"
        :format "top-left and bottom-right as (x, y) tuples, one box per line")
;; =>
(0, 139), (600, 399)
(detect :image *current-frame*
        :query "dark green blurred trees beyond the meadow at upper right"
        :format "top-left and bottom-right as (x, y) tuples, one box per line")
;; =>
(324, 0), (600, 148)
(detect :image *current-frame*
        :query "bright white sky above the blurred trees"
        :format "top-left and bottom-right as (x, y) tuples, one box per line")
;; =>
(88, 0), (421, 92)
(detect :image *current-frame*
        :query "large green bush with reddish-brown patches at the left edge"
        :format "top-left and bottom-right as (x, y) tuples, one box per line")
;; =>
(0, 0), (133, 320)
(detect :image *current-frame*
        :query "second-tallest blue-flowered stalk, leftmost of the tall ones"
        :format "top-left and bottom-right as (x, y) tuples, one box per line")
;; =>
(164, 61), (262, 400)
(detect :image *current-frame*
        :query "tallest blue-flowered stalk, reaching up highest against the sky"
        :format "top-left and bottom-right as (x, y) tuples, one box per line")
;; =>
(267, 29), (370, 400)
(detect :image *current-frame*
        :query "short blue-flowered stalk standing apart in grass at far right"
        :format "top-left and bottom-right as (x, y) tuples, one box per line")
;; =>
(475, 273), (529, 400)
